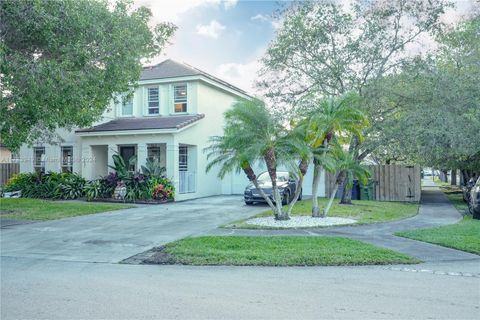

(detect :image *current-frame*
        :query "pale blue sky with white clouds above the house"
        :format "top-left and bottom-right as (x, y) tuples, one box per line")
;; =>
(135, 0), (475, 93)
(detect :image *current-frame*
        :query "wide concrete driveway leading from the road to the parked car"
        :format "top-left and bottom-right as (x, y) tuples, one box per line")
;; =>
(0, 196), (266, 262)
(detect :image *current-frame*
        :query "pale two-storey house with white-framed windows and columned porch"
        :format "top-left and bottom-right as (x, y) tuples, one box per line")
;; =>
(20, 60), (324, 200)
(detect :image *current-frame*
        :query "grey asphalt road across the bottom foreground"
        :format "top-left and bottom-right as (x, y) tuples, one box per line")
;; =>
(1, 258), (480, 320)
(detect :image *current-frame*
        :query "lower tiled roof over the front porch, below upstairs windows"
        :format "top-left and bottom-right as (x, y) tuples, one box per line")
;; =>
(75, 114), (205, 132)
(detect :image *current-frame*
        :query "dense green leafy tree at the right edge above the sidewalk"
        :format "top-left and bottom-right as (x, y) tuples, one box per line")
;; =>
(364, 16), (480, 180)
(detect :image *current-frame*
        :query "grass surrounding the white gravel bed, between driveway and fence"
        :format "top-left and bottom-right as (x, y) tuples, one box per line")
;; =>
(221, 198), (418, 229)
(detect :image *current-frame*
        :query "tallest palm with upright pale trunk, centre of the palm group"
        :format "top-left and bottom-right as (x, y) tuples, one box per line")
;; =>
(307, 93), (369, 217)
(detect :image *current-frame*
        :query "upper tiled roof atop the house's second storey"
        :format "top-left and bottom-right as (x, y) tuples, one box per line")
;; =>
(140, 59), (251, 97)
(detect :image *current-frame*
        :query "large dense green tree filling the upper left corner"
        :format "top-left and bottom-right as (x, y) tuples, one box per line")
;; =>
(0, 0), (175, 149)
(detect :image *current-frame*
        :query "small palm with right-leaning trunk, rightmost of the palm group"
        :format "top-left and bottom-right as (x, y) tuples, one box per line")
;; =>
(322, 148), (370, 217)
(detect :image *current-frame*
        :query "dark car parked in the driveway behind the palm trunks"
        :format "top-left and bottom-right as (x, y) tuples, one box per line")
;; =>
(244, 171), (302, 205)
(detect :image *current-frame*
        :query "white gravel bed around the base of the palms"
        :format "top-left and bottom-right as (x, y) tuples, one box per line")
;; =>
(245, 216), (357, 228)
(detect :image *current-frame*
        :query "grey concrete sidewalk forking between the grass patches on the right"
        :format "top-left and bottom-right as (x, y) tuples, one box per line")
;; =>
(209, 185), (480, 262)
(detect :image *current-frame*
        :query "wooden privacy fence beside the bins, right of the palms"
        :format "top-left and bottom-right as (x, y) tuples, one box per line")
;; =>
(325, 164), (421, 202)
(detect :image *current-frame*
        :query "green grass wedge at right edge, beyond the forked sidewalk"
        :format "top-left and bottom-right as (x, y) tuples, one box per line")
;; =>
(395, 217), (480, 255)
